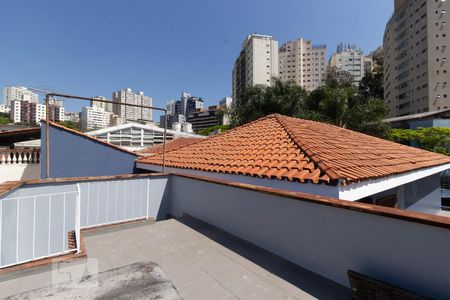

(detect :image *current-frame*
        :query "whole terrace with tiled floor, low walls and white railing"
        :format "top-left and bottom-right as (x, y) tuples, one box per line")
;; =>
(0, 174), (450, 299)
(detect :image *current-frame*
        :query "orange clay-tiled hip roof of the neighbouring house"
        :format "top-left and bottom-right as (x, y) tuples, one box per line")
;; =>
(138, 114), (450, 184)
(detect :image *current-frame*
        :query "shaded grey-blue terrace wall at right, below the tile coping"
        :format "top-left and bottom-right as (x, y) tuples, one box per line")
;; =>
(170, 176), (450, 299)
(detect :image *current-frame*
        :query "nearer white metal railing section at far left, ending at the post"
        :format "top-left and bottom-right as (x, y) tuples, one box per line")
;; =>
(0, 191), (80, 268)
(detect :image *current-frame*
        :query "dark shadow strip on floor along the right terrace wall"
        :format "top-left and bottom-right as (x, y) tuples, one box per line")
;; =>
(177, 215), (352, 300)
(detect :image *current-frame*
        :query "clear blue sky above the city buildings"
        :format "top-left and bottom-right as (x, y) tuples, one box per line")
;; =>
(0, 0), (394, 118)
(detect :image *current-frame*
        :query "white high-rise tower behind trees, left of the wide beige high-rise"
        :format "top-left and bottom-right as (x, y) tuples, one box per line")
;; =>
(233, 34), (278, 103)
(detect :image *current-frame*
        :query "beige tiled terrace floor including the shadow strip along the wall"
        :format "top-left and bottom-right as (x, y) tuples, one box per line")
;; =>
(0, 217), (351, 300)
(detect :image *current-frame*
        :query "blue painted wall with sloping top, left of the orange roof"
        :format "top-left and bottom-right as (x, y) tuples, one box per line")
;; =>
(41, 123), (137, 178)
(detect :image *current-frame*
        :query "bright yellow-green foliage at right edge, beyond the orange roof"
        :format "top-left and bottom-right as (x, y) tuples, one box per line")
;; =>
(388, 127), (450, 155)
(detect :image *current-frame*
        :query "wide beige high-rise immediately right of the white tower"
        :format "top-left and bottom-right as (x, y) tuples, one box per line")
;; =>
(278, 38), (327, 91)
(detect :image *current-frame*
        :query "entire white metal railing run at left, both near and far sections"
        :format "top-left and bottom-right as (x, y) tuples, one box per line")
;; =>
(0, 177), (167, 269)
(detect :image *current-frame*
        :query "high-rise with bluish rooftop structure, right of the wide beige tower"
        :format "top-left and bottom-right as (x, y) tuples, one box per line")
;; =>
(330, 43), (366, 85)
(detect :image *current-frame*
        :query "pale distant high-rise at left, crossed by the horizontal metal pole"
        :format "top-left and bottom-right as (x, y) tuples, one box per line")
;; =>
(112, 88), (152, 121)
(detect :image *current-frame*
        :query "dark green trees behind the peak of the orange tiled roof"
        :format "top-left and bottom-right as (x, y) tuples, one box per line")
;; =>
(231, 75), (389, 136)
